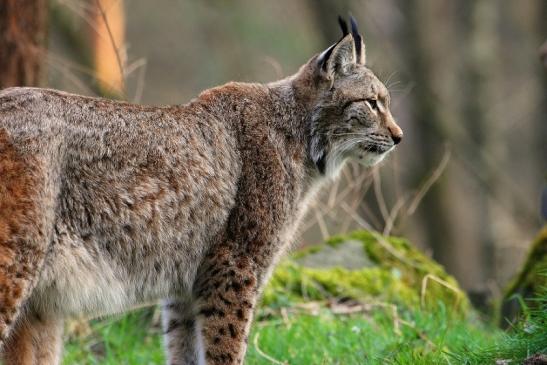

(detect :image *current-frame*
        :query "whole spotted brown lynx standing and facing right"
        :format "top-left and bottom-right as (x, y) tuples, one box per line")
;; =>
(0, 18), (403, 365)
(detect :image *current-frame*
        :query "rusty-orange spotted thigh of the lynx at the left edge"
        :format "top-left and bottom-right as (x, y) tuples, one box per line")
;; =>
(0, 133), (54, 351)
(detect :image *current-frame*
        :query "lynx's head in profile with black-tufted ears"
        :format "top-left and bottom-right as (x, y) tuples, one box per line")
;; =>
(293, 17), (403, 176)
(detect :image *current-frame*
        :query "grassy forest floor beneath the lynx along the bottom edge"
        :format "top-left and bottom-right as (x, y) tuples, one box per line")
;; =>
(63, 286), (547, 365)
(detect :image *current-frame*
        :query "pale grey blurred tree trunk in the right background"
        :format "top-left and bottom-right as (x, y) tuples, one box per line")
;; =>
(460, 0), (500, 307)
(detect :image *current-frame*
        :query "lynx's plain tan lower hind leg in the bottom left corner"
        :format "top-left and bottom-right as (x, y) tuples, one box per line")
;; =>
(3, 315), (63, 365)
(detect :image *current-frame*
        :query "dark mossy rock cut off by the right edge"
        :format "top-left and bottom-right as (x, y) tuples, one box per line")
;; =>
(501, 225), (547, 326)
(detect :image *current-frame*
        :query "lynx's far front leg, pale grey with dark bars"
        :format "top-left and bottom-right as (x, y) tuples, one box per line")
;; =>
(162, 299), (205, 365)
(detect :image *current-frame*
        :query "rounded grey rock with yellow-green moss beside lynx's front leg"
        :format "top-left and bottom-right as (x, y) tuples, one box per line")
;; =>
(263, 231), (469, 314)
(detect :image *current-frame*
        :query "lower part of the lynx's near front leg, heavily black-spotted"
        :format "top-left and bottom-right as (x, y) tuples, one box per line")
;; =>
(194, 255), (257, 364)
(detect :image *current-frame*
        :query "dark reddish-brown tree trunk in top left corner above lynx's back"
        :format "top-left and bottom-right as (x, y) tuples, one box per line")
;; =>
(0, 0), (48, 88)
